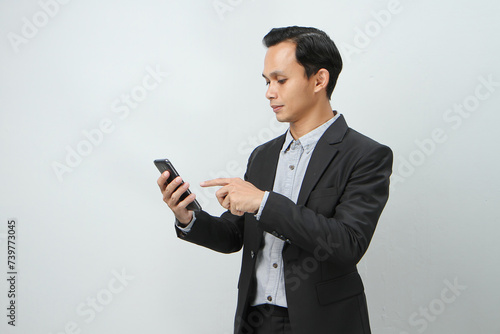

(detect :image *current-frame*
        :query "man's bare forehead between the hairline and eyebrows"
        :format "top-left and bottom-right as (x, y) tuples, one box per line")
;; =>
(262, 42), (304, 77)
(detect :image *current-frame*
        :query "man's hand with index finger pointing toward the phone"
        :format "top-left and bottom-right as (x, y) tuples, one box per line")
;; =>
(200, 177), (264, 216)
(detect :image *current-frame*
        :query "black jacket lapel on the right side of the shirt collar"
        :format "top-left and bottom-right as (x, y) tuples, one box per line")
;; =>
(297, 115), (348, 205)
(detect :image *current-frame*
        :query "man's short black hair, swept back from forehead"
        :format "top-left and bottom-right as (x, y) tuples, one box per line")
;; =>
(262, 26), (342, 99)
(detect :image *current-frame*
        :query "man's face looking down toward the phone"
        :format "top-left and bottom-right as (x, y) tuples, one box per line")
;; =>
(262, 42), (315, 123)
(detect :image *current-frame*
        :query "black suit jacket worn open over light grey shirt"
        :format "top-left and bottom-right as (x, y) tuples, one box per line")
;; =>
(177, 115), (392, 334)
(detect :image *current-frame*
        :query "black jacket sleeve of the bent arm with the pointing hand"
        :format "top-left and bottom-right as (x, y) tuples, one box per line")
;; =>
(259, 145), (393, 265)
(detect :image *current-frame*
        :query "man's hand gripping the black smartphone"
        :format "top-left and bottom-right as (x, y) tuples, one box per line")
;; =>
(158, 171), (196, 226)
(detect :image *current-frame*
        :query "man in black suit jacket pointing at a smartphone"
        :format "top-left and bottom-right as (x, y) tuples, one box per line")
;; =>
(158, 27), (392, 334)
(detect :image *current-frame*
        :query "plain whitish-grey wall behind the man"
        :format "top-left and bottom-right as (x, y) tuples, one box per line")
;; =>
(0, 0), (500, 334)
